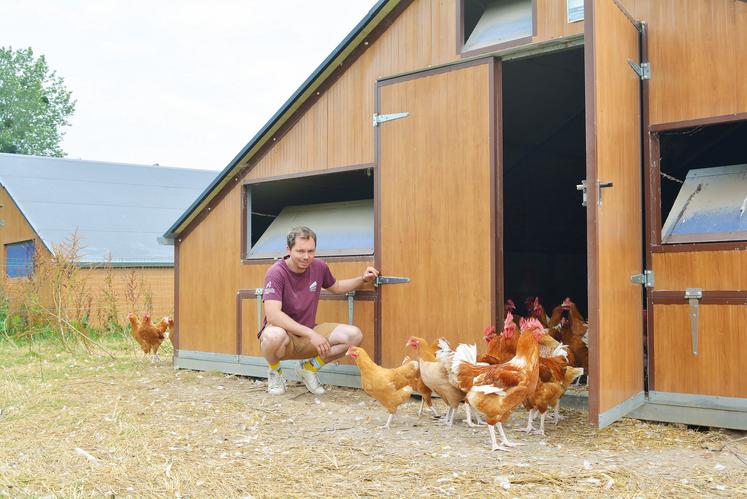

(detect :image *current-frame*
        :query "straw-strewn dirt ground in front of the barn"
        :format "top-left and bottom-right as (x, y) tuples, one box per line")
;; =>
(0, 340), (747, 497)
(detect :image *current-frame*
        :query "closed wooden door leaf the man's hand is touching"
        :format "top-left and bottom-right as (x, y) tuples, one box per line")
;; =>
(376, 60), (497, 366)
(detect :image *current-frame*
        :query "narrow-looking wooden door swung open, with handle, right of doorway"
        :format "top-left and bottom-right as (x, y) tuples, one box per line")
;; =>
(585, 0), (644, 427)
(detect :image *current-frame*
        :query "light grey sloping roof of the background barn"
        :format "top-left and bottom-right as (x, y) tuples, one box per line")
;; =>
(0, 154), (218, 265)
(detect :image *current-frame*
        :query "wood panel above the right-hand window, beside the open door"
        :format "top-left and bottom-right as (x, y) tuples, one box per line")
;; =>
(646, 0), (744, 124)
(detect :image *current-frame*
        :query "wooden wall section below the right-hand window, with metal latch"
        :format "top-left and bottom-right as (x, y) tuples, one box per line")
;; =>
(651, 250), (747, 397)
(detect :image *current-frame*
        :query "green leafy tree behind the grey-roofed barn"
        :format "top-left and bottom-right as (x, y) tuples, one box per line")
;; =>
(0, 47), (75, 157)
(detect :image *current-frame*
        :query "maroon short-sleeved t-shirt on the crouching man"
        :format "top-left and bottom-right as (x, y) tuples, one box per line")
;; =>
(258, 257), (336, 333)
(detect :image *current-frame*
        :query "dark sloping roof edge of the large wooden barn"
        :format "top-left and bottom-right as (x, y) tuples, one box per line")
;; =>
(163, 0), (403, 240)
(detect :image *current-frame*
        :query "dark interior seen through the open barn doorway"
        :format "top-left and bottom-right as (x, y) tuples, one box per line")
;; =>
(502, 48), (588, 317)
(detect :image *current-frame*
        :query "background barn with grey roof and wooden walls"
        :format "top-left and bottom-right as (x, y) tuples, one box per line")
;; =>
(0, 154), (217, 325)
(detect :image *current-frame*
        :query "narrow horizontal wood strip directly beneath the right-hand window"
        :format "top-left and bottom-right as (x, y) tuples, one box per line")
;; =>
(652, 250), (747, 291)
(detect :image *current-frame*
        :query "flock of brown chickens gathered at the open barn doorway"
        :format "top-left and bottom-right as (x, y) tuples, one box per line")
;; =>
(347, 297), (589, 451)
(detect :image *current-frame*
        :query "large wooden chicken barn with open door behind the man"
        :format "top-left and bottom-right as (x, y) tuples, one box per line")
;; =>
(165, 0), (747, 429)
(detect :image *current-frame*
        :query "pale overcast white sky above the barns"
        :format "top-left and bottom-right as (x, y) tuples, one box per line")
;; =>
(0, 0), (376, 170)
